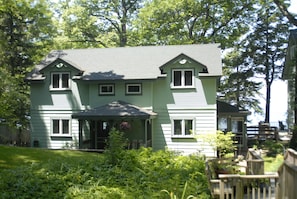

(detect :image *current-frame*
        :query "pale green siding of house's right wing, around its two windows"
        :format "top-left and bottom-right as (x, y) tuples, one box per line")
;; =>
(153, 70), (217, 157)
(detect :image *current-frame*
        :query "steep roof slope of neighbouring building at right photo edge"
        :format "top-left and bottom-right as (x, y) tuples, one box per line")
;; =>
(282, 29), (297, 79)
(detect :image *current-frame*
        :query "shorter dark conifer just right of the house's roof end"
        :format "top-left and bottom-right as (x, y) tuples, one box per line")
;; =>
(218, 49), (263, 114)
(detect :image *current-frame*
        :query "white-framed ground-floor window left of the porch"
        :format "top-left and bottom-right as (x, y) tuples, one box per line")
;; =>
(51, 118), (71, 136)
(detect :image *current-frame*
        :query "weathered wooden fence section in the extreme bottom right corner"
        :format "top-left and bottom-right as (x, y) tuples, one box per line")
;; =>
(278, 149), (297, 199)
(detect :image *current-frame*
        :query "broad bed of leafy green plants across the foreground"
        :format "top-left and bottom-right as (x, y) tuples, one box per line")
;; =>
(0, 147), (210, 199)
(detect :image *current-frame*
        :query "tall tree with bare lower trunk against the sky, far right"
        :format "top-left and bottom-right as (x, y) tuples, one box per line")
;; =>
(236, 0), (288, 123)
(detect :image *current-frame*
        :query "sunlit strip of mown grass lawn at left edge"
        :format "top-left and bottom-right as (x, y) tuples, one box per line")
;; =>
(0, 145), (100, 169)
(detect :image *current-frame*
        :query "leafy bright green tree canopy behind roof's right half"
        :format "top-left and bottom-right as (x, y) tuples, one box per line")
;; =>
(135, 0), (254, 48)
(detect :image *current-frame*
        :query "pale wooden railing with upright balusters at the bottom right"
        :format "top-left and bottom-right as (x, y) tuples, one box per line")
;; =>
(219, 174), (278, 199)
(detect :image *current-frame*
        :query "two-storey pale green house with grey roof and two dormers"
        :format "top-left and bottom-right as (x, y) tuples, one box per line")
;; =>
(27, 44), (222, 157)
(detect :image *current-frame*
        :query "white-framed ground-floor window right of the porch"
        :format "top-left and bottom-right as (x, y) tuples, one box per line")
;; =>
(172, 119), (194, 137)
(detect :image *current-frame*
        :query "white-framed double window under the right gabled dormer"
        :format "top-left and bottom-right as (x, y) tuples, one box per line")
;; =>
(172, 69), (194, 88)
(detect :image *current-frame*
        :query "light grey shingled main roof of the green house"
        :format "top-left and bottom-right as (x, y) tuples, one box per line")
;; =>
(27, 44), (222, 80)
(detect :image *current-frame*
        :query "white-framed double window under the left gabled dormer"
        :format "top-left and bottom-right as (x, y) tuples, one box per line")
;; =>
(51, 72), (70, 90)
